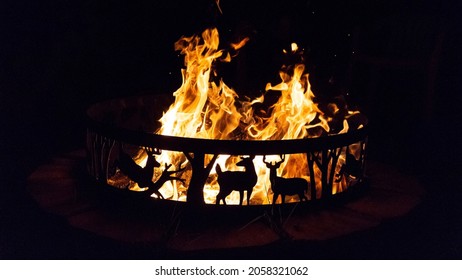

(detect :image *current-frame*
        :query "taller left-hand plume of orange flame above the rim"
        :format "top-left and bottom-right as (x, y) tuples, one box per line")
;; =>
(157, 29), (245, 139)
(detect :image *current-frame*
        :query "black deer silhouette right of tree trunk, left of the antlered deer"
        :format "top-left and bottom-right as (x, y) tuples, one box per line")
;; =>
(216, 156), (258, 205)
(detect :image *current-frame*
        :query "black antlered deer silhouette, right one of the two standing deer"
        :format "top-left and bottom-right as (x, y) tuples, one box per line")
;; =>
(263, 155), (308, 204)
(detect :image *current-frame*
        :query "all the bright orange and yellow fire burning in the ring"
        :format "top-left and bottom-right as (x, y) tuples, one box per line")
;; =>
(143, 27), (360, 204)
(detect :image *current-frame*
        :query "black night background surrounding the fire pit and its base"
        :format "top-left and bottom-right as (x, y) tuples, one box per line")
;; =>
(0, 0), (462, 259)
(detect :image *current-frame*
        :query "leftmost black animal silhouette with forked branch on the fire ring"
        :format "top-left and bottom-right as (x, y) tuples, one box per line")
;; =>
(117, 146), (184, 199)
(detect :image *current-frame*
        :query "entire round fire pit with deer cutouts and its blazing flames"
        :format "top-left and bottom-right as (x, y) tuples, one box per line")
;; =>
(87, 29), (367, 206)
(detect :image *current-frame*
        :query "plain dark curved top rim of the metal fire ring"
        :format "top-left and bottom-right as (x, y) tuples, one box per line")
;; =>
(86, 95), (368, 155)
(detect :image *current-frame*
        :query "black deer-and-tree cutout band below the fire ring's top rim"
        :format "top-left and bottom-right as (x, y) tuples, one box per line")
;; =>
(87, 132), (366, 205)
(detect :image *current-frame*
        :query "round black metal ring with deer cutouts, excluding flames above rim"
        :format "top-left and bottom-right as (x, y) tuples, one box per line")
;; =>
(87, 95), (367, 208)
